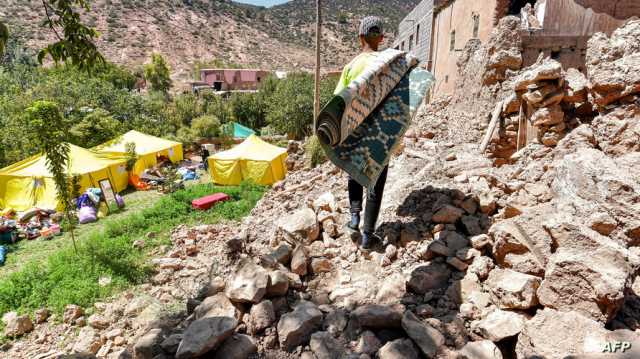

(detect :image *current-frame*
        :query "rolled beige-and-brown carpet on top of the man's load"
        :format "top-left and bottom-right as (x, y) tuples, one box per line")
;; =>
(316, 49), (416, 146)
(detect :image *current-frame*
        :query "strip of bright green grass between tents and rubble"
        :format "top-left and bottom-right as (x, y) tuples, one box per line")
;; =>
(0, 184), (265, 324)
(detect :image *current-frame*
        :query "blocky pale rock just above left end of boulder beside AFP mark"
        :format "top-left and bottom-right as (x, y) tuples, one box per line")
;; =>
(485, 268), (540, 309)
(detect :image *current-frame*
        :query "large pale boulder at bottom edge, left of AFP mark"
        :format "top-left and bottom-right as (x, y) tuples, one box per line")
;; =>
(516, 308), (606, 359)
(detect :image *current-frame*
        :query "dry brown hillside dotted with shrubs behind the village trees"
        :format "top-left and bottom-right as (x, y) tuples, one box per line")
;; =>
(0, 0), (418, 86)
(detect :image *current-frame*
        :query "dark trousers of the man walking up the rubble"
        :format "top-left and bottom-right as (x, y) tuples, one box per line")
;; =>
(348, 166), (389, 233)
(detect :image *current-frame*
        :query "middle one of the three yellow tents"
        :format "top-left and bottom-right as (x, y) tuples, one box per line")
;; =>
(94, 130), (183, 175)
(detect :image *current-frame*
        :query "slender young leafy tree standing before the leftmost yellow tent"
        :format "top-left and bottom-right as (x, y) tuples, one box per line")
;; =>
(26, 101), (78, 253)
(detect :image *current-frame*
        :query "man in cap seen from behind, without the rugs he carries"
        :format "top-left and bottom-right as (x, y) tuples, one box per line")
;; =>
(334, 16), (388, 250)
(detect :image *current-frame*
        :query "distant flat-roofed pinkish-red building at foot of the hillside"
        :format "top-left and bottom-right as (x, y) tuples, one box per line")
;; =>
(191, 69), (272, 91)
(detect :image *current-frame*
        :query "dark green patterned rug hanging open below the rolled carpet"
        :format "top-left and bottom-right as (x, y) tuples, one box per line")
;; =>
(318, 60), (435, 188)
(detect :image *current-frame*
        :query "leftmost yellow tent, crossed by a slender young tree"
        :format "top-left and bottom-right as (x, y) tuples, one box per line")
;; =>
(0, 144), (128, 211)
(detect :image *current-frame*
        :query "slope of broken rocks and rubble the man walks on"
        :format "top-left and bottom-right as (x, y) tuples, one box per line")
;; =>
(1, 19), (640, 359)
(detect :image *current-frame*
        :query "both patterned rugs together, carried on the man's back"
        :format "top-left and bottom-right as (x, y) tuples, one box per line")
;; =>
(315, 49), (435, 188)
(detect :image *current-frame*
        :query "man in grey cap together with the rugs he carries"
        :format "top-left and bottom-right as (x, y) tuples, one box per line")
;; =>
(315, 16), (434, 250)
